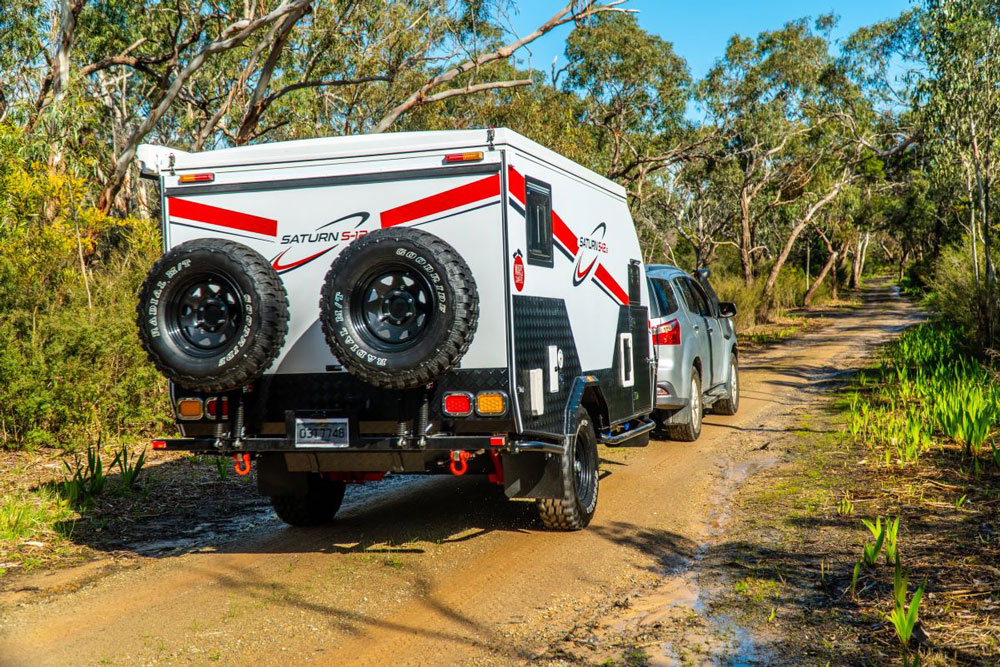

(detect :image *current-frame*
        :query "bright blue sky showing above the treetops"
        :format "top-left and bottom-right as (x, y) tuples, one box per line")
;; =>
(511, 0), (910, 79)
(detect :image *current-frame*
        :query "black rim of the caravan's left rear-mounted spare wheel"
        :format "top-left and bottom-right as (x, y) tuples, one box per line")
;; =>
(167, 274), (244, 357)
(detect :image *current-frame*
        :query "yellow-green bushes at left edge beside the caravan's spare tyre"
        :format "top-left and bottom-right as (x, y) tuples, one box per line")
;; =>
(0, 125), (167, 450)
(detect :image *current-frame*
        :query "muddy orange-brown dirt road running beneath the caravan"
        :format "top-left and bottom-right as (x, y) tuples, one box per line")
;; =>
(0, 287), (914, 666)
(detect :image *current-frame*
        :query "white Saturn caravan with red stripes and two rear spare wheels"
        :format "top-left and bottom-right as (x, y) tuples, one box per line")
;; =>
(138, 129), (653, 529)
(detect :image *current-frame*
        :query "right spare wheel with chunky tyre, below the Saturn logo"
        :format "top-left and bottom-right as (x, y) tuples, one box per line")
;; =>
(320, 227), (479, 389)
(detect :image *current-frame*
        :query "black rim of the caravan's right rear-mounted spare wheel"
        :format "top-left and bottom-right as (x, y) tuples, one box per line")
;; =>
(355, 266), (434, 350)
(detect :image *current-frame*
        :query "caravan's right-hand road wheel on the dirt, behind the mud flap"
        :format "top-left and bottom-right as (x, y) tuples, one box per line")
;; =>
(537, 408), (599, 530)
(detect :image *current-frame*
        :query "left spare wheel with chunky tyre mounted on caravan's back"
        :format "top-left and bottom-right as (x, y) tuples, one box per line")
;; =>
(136, 239), (288, 392)
